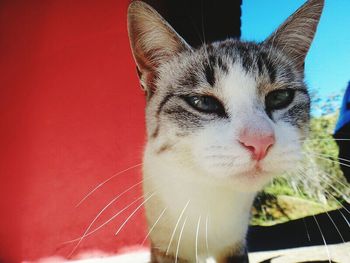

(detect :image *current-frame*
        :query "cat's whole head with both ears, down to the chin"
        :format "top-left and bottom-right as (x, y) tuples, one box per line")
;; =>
(128, 0), (323, 190)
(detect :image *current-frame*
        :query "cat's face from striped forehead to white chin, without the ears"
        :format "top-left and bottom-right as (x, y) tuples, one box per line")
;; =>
(147, 40), (310, 190)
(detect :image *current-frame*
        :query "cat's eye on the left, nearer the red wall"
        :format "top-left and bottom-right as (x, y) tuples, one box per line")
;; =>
(184, 96), (225, 116)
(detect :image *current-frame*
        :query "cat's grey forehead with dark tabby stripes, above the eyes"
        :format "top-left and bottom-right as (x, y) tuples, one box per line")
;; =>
(164, 39), (303, 93)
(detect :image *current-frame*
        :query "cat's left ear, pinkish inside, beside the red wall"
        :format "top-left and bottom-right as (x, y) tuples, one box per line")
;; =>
(128, 1), (191, 93)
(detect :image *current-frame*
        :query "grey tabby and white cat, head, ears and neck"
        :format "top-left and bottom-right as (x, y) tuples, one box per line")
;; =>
(128, 0), (324, 263)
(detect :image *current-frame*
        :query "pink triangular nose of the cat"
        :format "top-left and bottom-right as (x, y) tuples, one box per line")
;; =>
(238, 130), (275, 161)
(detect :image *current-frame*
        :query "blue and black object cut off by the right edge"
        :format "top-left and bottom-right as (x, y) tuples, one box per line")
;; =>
(334, 82), (350, 183)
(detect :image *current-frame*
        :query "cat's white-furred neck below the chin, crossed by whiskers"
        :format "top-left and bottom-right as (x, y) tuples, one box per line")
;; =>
(144, 147), (255, 257)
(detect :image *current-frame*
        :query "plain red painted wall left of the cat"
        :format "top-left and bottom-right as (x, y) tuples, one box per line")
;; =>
(0, 0), (145, 262)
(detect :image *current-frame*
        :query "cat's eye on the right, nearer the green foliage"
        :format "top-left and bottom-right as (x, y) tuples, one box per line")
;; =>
(265, 89), (295, 111)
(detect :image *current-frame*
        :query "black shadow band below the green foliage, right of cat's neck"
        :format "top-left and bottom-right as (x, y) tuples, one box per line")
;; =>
(247, 204), (350, 252)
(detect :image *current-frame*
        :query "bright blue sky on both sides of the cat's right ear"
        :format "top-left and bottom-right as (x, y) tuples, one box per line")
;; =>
(241, 0), (350, 112)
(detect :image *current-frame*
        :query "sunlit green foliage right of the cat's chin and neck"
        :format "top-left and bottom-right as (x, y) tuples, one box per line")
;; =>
(252, 113), (350, 225)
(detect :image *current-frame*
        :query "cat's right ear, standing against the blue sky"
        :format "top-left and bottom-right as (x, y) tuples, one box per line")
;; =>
(264, 0), (324, 71)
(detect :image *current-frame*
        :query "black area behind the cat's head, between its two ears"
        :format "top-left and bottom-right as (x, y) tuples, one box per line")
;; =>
(144, 0), (242, 47)
